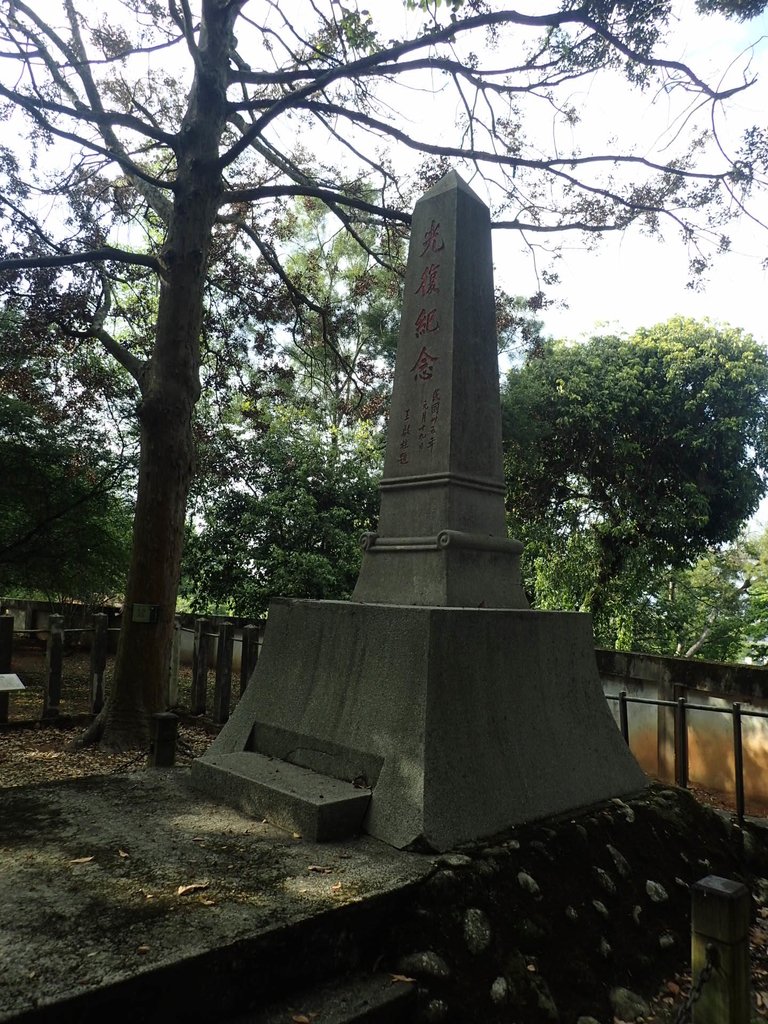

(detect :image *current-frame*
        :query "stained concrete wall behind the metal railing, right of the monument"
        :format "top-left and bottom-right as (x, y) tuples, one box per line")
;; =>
(596, 649), (768, 811)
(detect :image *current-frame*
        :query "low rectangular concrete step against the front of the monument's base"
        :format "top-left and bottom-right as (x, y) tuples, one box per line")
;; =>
(191, 751), (371, 843)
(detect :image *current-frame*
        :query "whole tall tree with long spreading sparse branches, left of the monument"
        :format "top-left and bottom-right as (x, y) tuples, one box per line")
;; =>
(0, 0), (764, 746)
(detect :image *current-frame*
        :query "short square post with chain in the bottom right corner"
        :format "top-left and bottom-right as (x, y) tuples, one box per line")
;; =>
(691, 874), (752, 1024)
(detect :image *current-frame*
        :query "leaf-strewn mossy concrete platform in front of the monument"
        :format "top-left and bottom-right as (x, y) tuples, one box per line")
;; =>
(0, 768), (433, 1024)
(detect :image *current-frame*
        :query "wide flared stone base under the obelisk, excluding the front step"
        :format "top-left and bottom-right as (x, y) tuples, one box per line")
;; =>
(193, 601), (646, 850)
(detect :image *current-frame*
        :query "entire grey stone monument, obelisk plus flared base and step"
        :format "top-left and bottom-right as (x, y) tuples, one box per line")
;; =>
(193, 172), (646, 850)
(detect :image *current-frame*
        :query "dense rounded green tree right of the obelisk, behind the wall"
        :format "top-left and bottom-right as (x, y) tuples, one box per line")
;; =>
(503, 317), (768, 646)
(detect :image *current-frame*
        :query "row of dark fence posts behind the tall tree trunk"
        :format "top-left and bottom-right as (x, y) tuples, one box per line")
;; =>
(0, 612), (260, 725)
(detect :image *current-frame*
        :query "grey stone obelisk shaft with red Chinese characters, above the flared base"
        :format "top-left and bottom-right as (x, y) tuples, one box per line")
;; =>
(352, 171), (527, 608)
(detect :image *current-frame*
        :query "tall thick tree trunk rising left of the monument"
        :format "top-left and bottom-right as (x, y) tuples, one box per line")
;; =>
(91, 0), (241, 750)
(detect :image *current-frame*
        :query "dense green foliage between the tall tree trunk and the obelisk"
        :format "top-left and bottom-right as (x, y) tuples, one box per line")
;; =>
(181, 406), (379, 616)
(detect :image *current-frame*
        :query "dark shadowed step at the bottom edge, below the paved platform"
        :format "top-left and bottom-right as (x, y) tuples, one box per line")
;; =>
(226, 974), (416, 1024)
